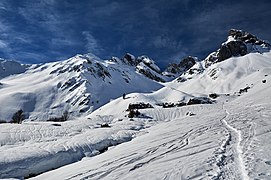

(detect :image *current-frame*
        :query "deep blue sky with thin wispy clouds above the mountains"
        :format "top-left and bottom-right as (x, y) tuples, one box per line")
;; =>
(0, 0), (271, 66)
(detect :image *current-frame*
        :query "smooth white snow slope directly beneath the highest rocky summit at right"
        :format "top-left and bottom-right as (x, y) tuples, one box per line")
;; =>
(171, 52), (271, 94)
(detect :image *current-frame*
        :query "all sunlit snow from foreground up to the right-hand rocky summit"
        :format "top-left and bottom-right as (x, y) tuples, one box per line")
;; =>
(0, 53), (271, 179)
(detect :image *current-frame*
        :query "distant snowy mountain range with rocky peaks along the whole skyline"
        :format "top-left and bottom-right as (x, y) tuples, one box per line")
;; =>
(0, 29), (271, 121)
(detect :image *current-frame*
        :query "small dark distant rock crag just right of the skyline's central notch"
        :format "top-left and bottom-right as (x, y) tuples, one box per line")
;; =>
(163, 56), (197, 77)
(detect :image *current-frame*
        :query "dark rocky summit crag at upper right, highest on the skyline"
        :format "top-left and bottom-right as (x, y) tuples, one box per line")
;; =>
(205, 29), (271, 67)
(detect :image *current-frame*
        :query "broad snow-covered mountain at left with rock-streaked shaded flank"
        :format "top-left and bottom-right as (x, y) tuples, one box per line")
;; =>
(0, 54), (162, 121)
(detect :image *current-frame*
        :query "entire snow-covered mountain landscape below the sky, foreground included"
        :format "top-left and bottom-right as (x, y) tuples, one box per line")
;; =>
(0, 30), (271, 179)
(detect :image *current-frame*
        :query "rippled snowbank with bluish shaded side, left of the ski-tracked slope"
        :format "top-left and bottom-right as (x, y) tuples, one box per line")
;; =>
(0, 112), (149, 178)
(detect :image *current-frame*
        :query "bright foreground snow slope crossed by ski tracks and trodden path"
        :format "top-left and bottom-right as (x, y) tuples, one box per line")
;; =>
(33, 83), (271, 179)
